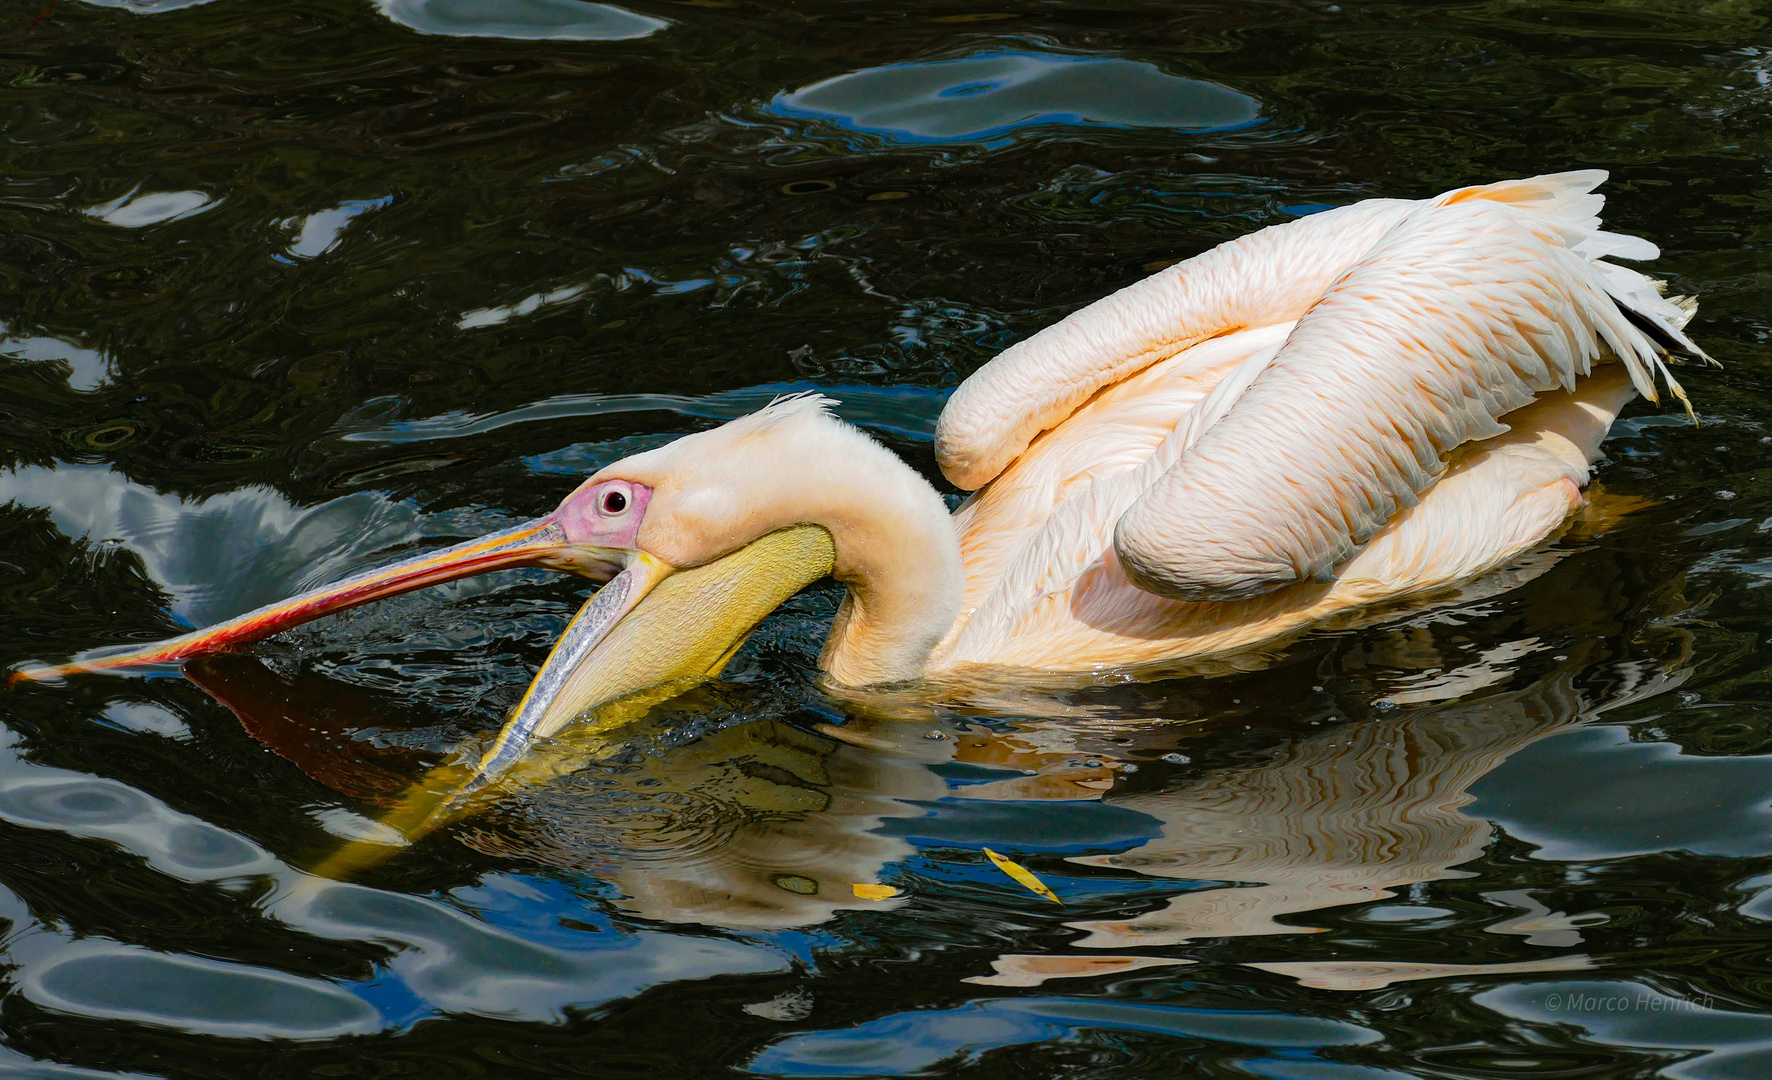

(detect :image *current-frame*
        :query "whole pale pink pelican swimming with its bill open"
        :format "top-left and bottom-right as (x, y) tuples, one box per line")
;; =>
(14, 170), (1708, 782)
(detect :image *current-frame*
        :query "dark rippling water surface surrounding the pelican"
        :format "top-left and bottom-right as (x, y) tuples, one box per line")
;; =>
(0, 0), (1772, 1080)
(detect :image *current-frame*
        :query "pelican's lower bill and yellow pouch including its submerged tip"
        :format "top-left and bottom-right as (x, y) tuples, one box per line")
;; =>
(315, 525), (836, 878)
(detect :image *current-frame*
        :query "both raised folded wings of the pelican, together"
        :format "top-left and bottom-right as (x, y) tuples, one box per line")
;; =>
(936, 170), (1701, 599)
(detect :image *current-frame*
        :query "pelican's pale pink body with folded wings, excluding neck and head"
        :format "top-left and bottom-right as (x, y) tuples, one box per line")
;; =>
(937, 172), (1701, 669)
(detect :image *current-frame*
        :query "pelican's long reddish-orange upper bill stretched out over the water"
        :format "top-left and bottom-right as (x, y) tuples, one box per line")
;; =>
(7, 518), (629, 686)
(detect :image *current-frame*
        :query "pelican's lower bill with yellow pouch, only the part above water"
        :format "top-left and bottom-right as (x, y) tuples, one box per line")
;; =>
(461, 525), (836, 796)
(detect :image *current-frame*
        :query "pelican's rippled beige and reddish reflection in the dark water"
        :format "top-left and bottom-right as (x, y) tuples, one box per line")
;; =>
(176, 539), (1690, 988)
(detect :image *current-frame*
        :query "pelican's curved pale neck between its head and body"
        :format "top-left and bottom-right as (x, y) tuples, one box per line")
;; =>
(813, 424), (966, 686)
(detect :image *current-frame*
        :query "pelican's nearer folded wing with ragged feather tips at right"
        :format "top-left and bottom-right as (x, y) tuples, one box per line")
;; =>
(1115, 174), (1696, 599)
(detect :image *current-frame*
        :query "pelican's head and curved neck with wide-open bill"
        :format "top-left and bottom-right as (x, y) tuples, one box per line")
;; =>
(16, 394), (962, 786)
